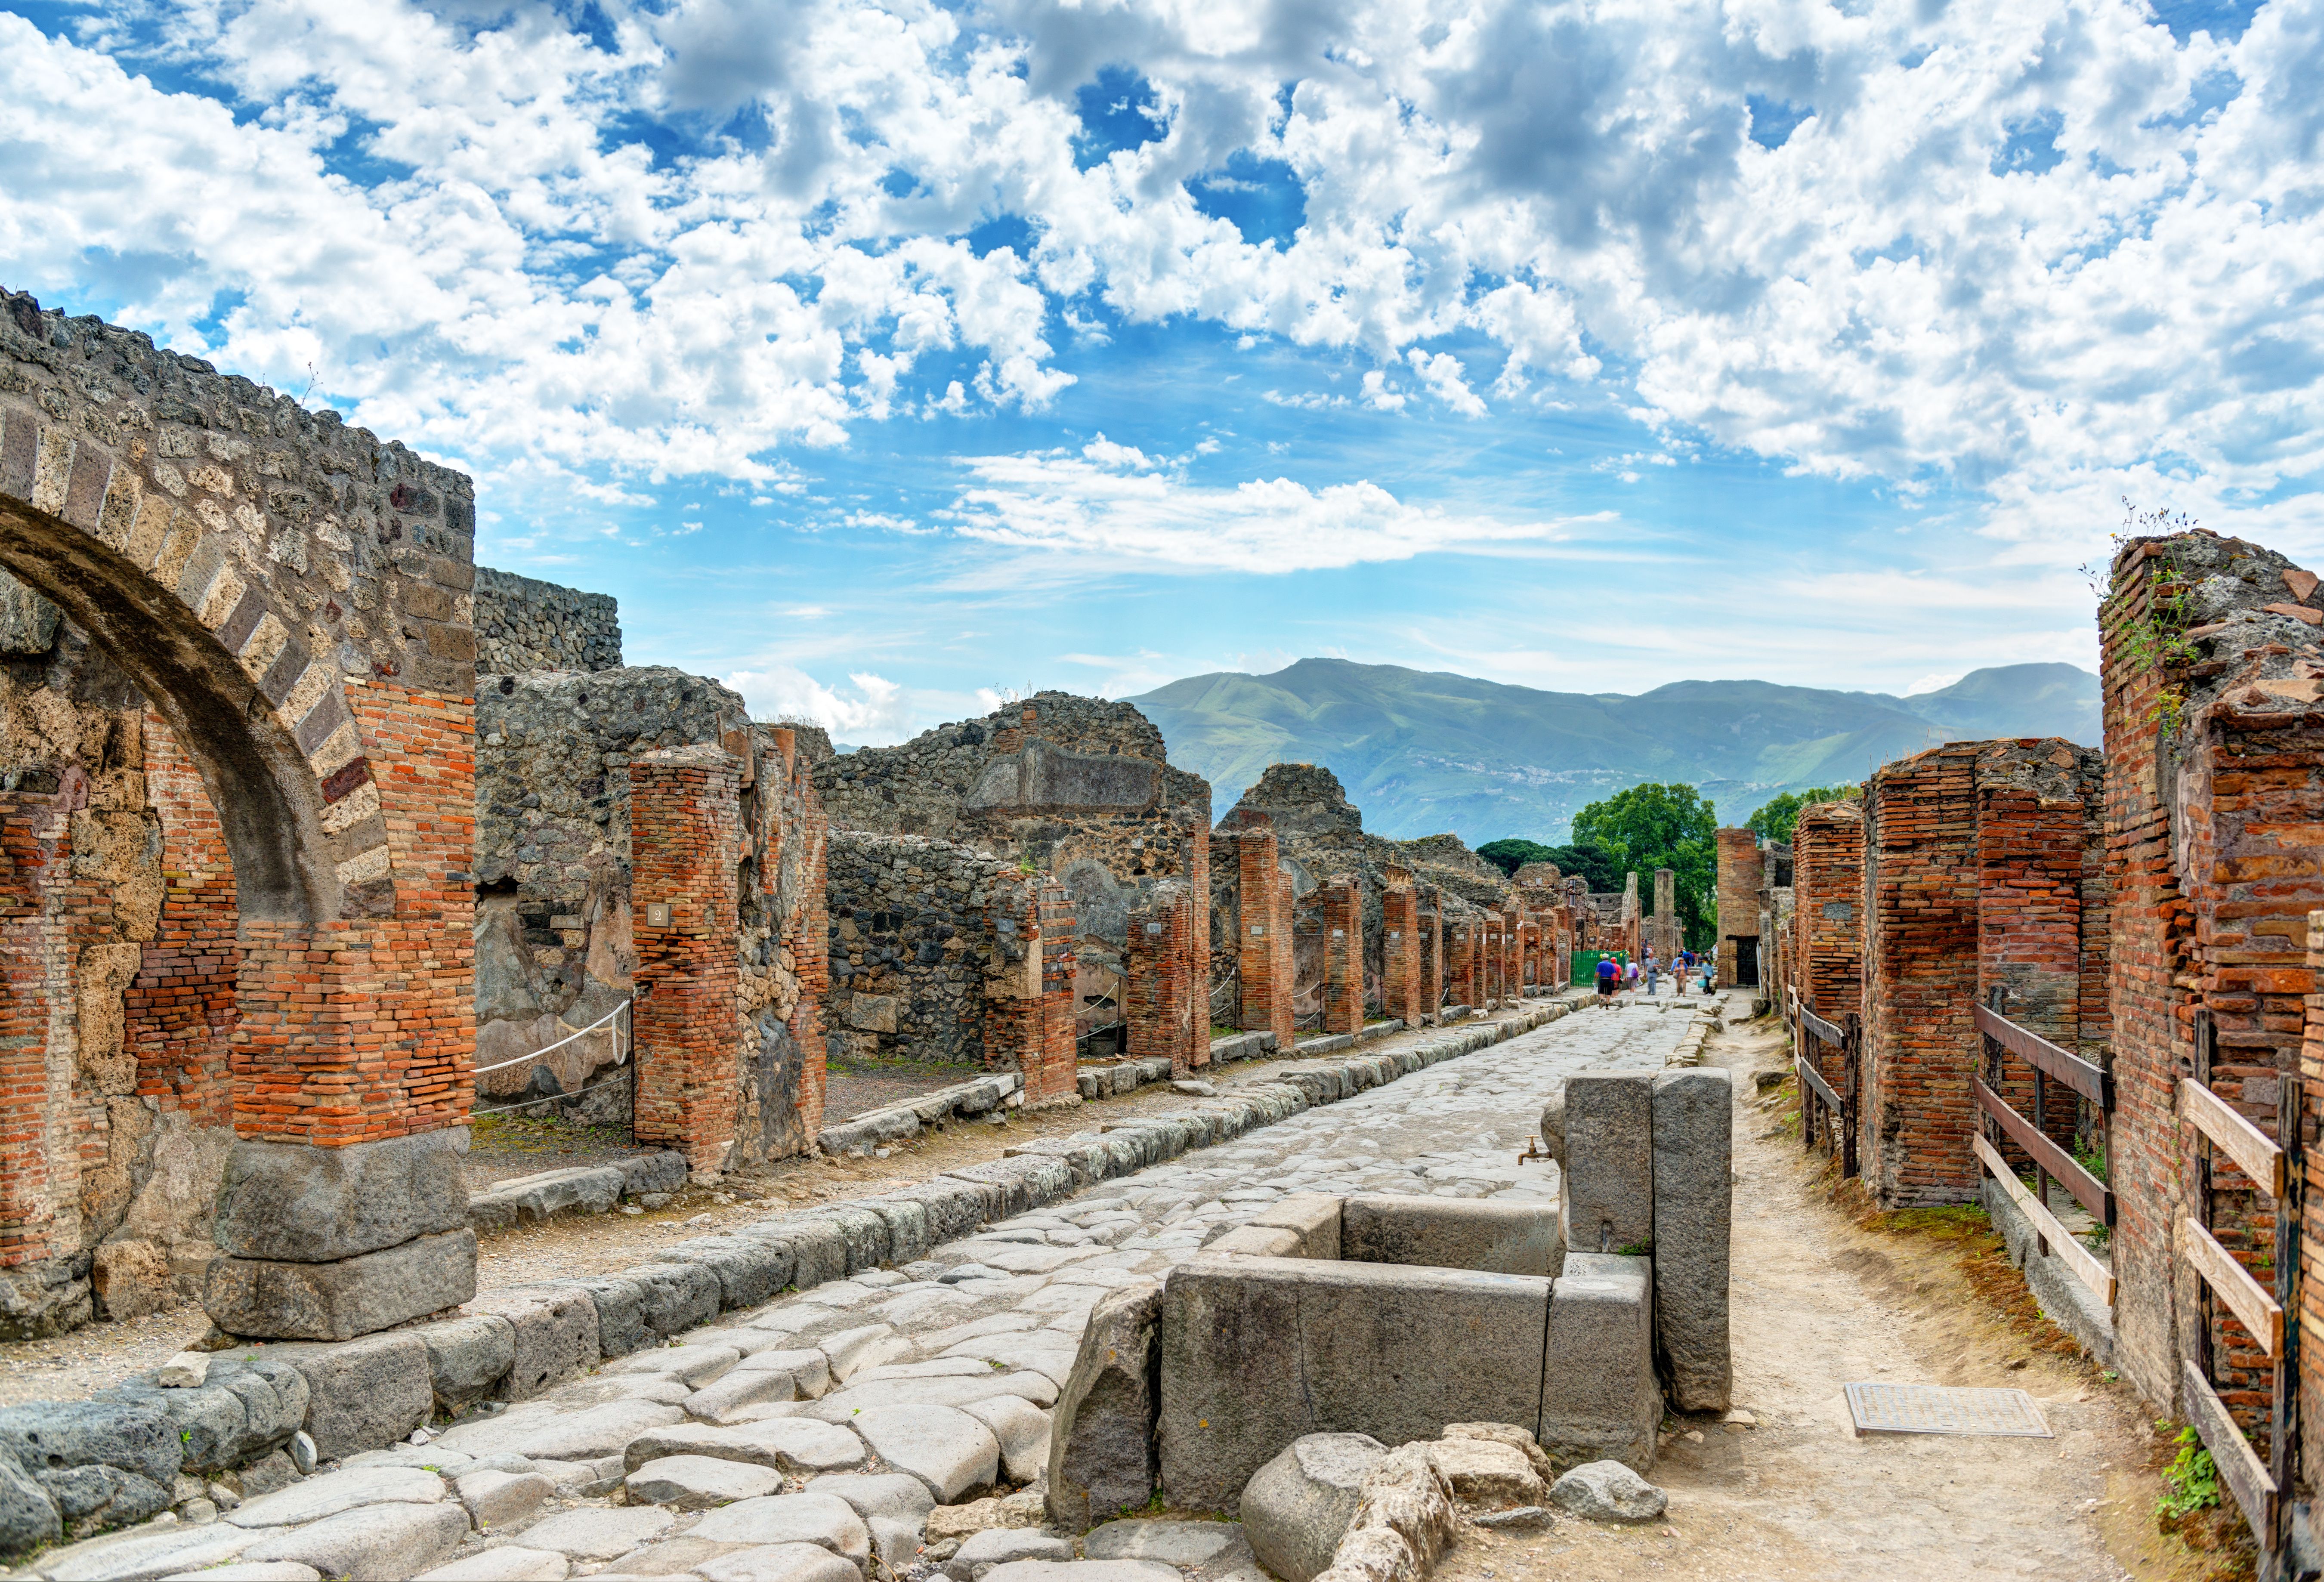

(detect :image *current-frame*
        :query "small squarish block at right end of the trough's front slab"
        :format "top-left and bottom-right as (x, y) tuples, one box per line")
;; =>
(1534, 1252), (1662, 1473)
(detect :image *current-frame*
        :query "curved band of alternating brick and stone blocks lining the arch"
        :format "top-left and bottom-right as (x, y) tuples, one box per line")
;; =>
(0, 397), (393, 922)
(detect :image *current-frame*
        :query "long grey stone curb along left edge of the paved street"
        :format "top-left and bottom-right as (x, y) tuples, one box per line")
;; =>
(0, 1001), (1578, 1551)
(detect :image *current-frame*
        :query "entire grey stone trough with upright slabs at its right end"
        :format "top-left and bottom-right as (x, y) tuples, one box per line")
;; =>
(1048, 1069), (1731, 1526)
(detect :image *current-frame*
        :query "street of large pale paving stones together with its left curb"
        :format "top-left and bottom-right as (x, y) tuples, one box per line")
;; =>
(0, 1006), (1694, 1582)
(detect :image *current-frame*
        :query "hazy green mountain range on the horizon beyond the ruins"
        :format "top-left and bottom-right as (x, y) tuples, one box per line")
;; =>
(1127, 660), (2101, 846)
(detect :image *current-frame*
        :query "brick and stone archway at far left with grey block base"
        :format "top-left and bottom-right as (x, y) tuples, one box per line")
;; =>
(0, 293), (474, 1336)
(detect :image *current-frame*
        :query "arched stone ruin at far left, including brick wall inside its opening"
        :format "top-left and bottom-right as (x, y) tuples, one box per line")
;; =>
(0, 293), (476, 1336)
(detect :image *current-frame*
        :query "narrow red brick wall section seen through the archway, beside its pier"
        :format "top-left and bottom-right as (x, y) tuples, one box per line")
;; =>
(126, 708), (242, 1127)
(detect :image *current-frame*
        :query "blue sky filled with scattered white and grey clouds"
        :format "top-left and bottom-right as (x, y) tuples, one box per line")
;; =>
(0, 0), (2324, 741)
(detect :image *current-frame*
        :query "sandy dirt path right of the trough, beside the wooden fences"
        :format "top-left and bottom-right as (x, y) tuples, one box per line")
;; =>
(1439, 1024), (2208, 1582)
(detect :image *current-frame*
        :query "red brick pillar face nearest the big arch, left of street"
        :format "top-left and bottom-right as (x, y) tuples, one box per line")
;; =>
(630, 746), (742, 1175)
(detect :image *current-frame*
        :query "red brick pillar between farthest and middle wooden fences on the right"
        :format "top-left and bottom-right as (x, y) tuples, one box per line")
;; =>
(1850, 743), (1982, 1208)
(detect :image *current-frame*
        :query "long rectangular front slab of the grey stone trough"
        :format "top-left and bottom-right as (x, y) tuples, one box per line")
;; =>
(1160, 1254), (1550, 1510)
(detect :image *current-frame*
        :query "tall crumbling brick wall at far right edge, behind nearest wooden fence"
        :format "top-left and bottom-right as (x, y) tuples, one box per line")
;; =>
(2098, 532), (2324, 1438)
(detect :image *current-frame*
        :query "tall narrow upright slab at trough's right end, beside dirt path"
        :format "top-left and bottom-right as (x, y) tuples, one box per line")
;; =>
(1655, 1066), (1734, 1412)
